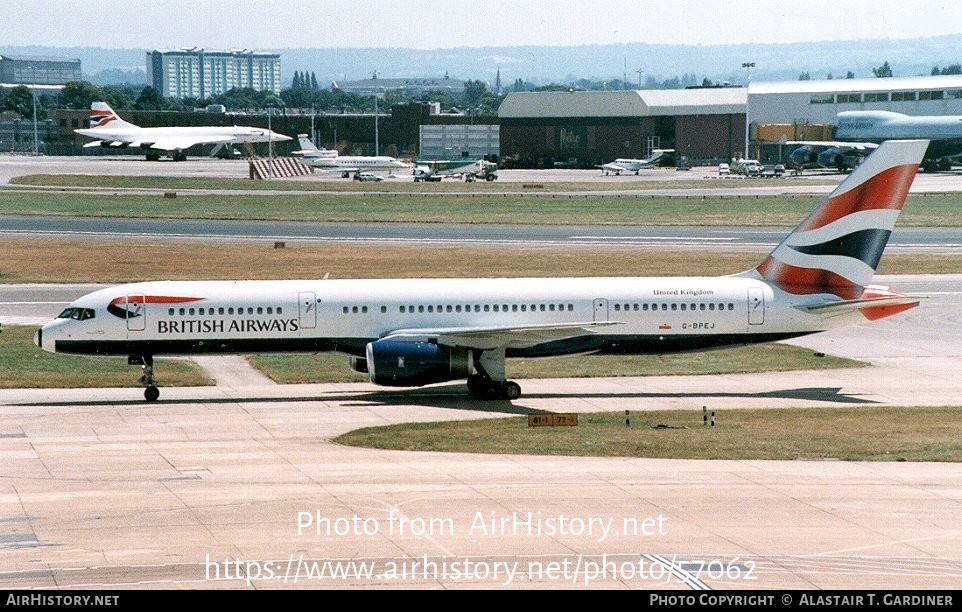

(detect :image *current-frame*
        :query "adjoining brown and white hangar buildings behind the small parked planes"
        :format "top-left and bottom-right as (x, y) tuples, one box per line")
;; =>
(498, 75), (962, 167)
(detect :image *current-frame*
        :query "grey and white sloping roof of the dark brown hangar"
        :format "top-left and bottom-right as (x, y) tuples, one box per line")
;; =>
(498, 87), (748, 119)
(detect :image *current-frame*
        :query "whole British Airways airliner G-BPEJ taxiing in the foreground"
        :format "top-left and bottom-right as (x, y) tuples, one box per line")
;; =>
(35, 140), (928, 400)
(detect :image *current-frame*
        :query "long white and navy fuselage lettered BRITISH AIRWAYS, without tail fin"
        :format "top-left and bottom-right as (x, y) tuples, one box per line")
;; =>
(38, 278), (850, 357)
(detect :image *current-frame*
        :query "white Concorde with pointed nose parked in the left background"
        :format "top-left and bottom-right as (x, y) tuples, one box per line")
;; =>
(74, 102), (291, 161)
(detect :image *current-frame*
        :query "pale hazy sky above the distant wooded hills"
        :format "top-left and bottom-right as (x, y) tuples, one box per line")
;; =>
(0, 0), (962, 52)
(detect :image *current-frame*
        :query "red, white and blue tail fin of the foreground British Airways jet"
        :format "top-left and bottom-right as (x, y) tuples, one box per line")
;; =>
(744, 140), (928, 300)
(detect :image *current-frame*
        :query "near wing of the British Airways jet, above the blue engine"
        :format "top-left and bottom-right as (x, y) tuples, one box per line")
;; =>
(381, 321), (621, 350)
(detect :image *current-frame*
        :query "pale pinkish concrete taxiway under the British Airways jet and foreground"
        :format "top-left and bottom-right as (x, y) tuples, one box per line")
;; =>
(0, 276), (962, 591)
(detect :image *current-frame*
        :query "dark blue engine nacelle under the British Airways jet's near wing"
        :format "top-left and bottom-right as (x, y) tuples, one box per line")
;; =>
(364, 340), (474, 387)
